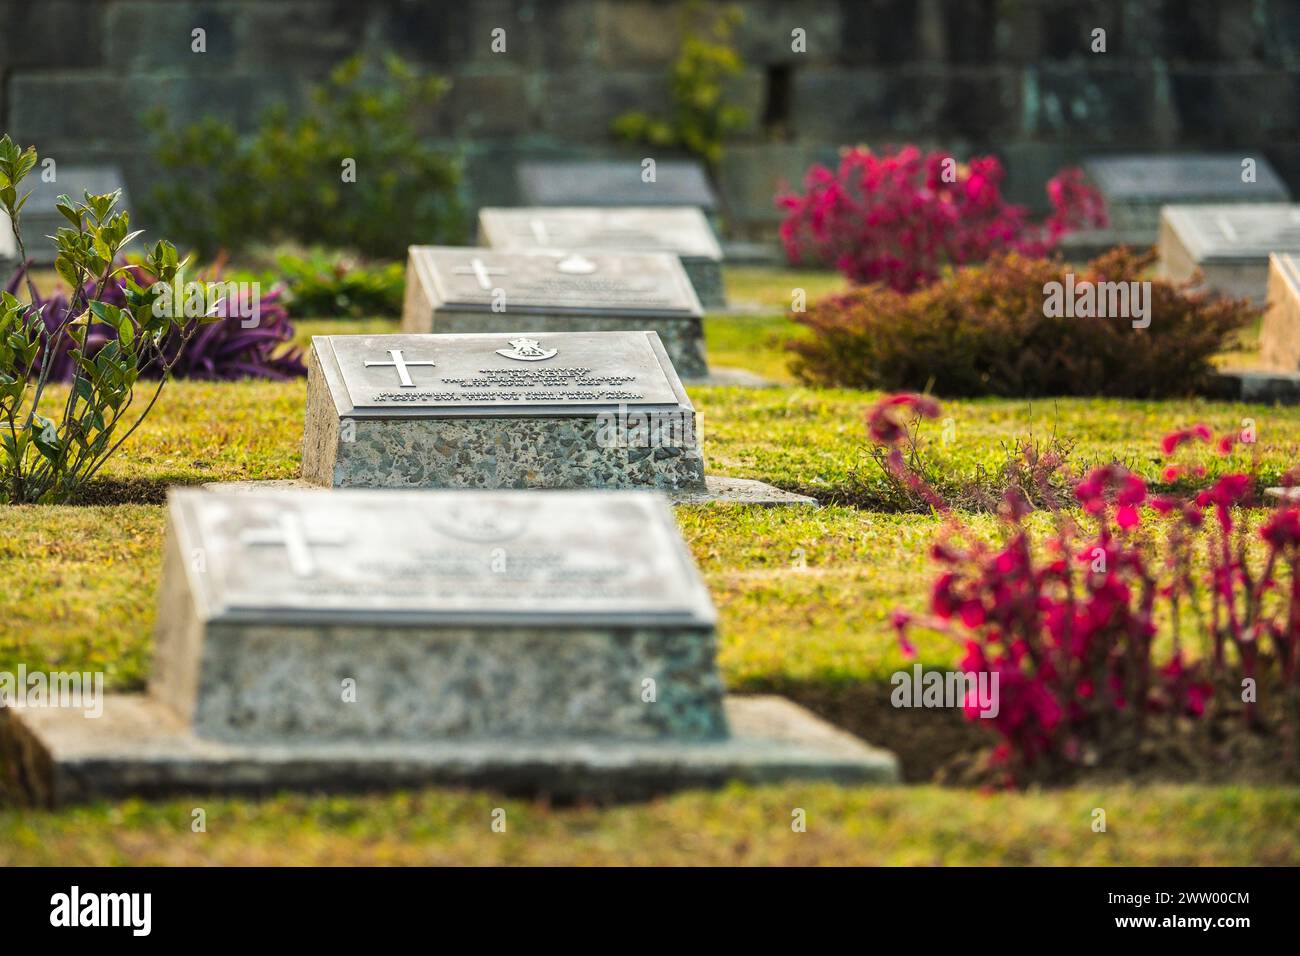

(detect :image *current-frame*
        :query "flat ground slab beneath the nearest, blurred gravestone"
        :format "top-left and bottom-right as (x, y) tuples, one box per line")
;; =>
(0, 695), (898, 805)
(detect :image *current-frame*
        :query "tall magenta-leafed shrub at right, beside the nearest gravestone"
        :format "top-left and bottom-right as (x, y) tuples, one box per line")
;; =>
(868, 395), (1300, 783)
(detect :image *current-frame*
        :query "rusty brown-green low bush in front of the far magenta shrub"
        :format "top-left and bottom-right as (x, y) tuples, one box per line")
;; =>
(788, 248), (1258, 398)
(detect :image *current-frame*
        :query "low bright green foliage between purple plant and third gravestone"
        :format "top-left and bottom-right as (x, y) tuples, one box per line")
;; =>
(231, 247), (406, 319)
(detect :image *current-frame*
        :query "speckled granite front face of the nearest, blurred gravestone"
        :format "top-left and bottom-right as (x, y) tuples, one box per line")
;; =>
(150, 624), (727, 745)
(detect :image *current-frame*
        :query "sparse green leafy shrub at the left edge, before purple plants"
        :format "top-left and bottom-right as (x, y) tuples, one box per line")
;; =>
(0, 135), (200, 503)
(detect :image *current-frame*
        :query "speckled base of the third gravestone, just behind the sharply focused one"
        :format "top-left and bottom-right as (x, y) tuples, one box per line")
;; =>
(402, 307), (709, 378)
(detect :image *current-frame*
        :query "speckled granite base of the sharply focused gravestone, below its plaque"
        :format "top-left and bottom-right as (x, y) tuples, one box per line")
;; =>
(302, 362), (705, 490)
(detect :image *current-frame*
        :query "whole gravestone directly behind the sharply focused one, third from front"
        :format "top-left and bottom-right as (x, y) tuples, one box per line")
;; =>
(402, 246), (709, 378)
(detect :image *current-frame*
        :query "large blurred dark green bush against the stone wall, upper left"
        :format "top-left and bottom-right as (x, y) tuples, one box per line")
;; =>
(146, 55), (464, 258)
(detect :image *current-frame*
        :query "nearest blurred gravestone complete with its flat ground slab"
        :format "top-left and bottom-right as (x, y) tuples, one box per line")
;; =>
(0, 489), (897, 804)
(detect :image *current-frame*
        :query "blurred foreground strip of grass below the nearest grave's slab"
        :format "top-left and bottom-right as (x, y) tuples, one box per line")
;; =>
(0, 783), (1300, 866)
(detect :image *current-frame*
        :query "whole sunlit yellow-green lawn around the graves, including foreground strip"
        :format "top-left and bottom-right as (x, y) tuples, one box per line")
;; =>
(0, 269), (1300, 865)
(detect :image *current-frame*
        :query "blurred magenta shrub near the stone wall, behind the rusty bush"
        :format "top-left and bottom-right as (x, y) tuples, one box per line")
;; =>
(776, 146), (1106, 291)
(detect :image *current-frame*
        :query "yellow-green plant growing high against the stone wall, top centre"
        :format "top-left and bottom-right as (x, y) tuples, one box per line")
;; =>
(611, 4), (748, 170)
